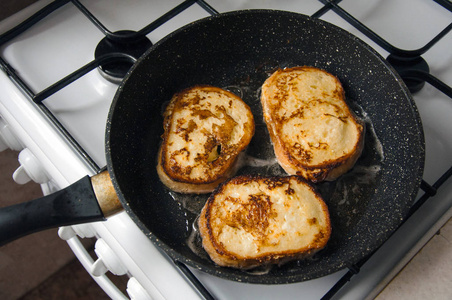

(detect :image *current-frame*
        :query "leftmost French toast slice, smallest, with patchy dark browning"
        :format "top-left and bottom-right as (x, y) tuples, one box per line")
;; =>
(157, 86), (254, 194)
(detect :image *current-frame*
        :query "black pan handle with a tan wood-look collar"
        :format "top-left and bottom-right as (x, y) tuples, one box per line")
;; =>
(0, 171), (122, 246)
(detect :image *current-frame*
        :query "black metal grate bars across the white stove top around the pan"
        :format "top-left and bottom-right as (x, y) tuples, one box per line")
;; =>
(0, 0), (452, 299)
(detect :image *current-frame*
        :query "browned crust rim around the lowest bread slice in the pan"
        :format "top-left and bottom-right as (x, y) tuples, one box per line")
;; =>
(198, 175), (331, 269)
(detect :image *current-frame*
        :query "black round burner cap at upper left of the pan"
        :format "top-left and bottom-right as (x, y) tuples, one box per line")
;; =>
(94, 30), (152, 83)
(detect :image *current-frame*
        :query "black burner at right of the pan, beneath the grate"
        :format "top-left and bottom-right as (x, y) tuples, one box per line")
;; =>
(386, 54), (430, 93)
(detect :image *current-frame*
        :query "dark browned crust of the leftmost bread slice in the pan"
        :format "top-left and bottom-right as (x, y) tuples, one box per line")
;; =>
(157, 85), (255, 194)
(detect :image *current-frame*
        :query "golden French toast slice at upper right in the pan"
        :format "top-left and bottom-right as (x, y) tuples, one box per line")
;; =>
(261, 66), (364, 182)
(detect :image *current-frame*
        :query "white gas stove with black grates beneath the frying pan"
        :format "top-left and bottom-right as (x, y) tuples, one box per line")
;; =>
(0, 0), (452, 299)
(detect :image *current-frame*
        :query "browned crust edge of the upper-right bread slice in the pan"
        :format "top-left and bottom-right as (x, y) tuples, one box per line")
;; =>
(261, 66), (365, 182)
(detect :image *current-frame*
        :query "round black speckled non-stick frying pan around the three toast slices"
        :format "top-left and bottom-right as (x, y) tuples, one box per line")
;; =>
(0, 10), (424, 284)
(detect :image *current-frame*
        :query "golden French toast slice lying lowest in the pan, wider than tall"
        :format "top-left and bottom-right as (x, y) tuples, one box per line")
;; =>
(198, 175), (331, 269)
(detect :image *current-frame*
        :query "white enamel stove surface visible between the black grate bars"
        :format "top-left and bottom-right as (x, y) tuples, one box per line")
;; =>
(0, 0), (452, 299)
